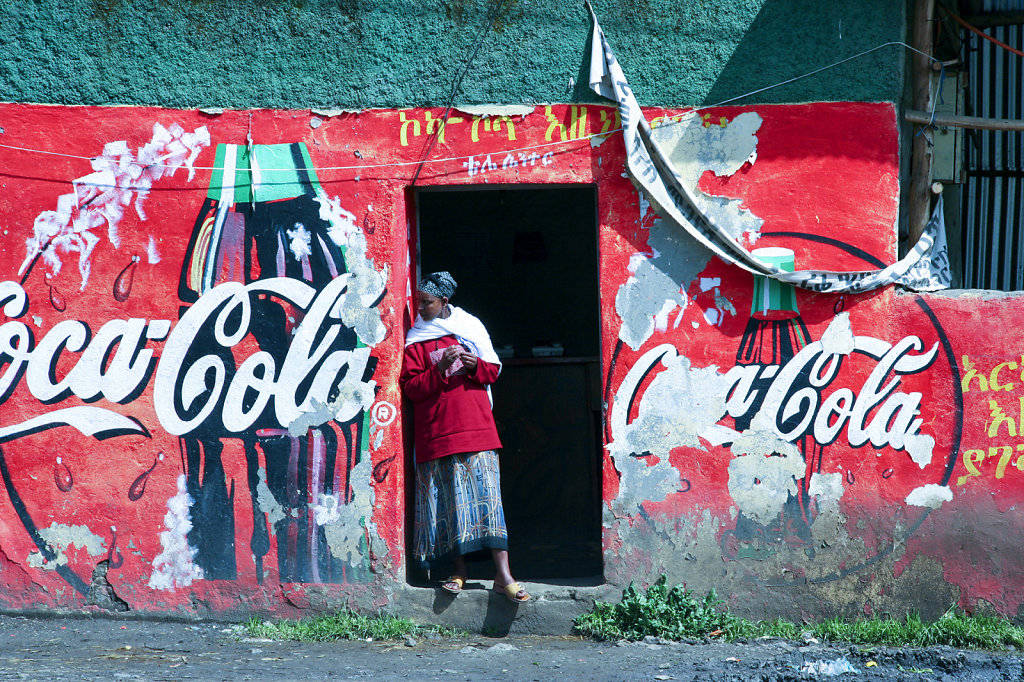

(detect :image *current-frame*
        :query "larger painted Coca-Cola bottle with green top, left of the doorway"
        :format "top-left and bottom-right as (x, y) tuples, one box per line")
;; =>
(178, 143), (365, 583)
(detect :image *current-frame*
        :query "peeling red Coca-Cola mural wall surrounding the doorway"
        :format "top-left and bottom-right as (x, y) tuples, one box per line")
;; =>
(0, 99), (1024, 614)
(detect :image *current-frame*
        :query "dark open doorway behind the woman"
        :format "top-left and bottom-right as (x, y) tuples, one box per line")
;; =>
(410, 185), (602, 583)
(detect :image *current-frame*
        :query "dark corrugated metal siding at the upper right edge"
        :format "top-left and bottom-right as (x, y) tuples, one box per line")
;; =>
(963, 20), (1024, 291)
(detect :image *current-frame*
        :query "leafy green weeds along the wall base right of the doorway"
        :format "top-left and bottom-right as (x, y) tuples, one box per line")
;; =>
(574, 576), (1024, 650)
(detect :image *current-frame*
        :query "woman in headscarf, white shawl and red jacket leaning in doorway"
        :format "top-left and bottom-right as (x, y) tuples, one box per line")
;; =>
(399, 272), (529, 603)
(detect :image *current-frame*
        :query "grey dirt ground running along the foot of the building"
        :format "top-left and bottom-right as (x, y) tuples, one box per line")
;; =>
(0, 615), (1024, 681)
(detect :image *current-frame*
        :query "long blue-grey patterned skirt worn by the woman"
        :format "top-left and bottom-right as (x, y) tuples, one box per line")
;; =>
(413, 450), (508, 568)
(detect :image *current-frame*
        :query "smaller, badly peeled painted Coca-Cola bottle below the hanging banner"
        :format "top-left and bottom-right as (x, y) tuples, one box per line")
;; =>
(730, 248), (822, 556)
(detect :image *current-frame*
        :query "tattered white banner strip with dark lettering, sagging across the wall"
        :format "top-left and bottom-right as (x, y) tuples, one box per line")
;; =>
(587, 2), (950, 294)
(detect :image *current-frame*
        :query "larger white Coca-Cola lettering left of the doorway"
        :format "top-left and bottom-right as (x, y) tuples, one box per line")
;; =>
(0, 274), (375, 439)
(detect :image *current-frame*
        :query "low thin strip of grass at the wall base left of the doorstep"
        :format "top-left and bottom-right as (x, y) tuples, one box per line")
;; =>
(245, 609), (465, 642)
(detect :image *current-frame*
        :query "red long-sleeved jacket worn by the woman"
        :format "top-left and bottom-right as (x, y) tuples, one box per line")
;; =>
(398, 336), (502, 462)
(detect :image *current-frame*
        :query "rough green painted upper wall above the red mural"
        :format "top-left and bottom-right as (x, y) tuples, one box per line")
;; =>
(0, 0), (905, 109)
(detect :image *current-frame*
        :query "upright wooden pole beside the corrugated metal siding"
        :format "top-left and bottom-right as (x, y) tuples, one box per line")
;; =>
(907, 0), (935, 248)
